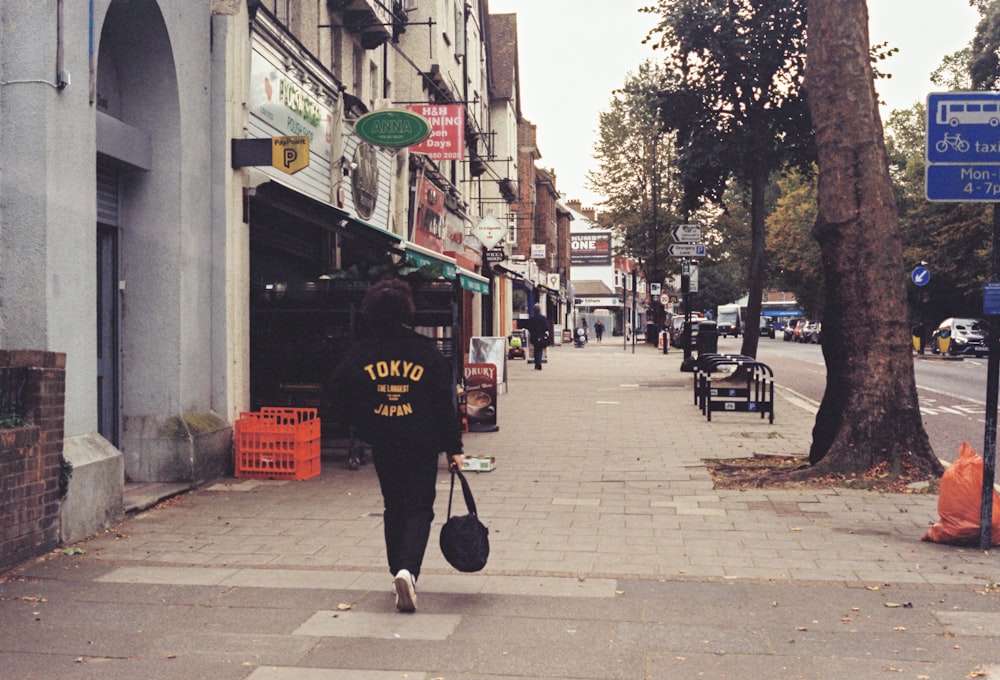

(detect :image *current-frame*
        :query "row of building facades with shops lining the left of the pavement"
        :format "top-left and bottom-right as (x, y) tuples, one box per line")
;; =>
(0, 0), (568, 540)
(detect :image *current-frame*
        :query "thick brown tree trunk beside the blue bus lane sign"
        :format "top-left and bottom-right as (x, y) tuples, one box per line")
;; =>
(807, 0), (941, 476)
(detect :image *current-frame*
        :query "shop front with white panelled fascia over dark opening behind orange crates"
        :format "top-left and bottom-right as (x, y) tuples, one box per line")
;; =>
(243, 10), (406, 429)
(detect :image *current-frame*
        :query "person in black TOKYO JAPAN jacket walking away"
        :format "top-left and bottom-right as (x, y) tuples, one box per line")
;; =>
(328, 279), (462, 612)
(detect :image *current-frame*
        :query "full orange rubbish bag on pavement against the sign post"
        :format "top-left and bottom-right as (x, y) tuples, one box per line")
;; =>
(920, 442), (1000, 546)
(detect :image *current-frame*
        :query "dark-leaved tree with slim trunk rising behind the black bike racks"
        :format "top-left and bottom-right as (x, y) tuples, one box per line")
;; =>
(648, 0), (813, 356)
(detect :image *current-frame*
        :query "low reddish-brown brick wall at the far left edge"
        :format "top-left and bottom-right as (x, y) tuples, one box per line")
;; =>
(0, 350), (66, 573)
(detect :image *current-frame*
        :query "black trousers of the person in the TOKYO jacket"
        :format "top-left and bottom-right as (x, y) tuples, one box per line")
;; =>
(372, 449), (438, 579)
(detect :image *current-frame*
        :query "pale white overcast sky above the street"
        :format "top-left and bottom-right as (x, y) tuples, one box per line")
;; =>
(490, 0), (978, 206)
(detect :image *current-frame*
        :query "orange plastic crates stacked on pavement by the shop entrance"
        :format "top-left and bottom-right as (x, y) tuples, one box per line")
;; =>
(233, 406), (320, 479)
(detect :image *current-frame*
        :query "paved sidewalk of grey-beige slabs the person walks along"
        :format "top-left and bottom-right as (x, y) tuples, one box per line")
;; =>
(0, 338), (1000, 680)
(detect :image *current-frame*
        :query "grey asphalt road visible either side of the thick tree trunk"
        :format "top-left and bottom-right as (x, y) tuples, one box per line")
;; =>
(719, 335), (987, 461)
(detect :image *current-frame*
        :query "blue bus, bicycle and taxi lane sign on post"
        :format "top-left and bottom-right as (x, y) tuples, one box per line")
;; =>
(925, 92), (1000, 203)
